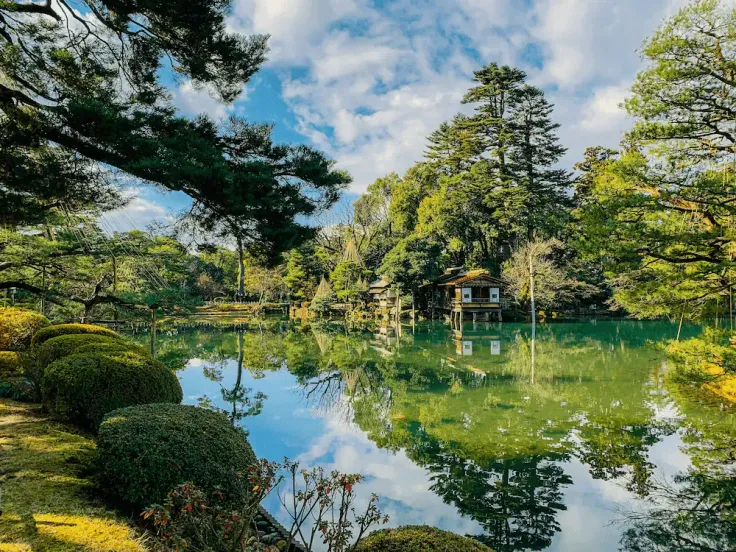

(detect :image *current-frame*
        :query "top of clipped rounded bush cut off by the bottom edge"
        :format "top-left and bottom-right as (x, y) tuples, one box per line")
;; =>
(356, 525), (493, 552)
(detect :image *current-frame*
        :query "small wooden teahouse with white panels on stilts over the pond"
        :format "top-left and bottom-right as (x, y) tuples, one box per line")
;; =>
(422, 267), (505, 323)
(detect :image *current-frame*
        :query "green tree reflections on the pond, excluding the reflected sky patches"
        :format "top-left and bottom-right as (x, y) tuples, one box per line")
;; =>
(137, 322), (736, 552)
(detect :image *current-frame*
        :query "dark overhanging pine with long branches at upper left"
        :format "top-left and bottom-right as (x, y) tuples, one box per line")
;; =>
(0, 0), (349, 257)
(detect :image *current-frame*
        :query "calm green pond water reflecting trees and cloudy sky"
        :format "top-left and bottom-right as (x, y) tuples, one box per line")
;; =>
(134, 321), (736, 552)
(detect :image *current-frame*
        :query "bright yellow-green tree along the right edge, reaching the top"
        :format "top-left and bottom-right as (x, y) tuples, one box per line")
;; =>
(580, 0), (736, 319)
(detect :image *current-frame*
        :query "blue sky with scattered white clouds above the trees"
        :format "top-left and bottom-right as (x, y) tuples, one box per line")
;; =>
(112, 0), (685, 229)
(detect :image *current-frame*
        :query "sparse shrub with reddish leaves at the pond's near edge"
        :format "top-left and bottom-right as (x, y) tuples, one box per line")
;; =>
(142, 460), (388, 552)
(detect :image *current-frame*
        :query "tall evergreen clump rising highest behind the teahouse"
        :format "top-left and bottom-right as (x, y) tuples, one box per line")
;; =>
(416, 63), (570, 267)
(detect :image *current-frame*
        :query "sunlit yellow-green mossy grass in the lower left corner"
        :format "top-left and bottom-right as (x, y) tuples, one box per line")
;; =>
(0, 399), (146, 552)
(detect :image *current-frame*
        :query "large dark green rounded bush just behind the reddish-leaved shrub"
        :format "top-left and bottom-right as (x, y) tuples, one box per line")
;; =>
(97, 404), (256, 507)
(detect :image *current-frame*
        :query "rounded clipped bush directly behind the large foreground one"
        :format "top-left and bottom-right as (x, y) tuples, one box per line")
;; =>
(42, 352), (182, 429)
